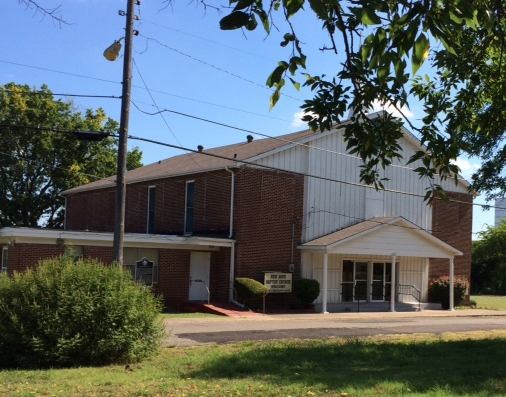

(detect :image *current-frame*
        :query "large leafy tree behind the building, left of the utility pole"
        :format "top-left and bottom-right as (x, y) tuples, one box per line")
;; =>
(0, 83), (142, 228)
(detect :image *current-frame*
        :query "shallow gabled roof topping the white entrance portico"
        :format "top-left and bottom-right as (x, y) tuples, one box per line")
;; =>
(299, 216), (463, 258)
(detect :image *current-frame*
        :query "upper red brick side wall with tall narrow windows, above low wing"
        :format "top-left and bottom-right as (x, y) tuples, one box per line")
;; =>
(66, 170), (231, 235)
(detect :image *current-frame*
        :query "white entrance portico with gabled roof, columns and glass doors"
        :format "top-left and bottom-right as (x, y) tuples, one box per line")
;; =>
(298, 217), (462, 313)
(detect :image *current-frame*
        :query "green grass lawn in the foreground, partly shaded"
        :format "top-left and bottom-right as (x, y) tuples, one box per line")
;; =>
(0, 331), (506, 396)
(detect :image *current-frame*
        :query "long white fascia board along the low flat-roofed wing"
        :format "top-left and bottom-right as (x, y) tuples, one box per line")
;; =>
(0, 228), (234, 248)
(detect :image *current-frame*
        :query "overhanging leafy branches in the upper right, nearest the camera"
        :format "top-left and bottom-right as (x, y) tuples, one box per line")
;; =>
(220, 0), (506, 198)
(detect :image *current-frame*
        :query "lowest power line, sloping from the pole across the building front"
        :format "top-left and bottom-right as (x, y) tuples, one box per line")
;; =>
(0, 124), (490, 209)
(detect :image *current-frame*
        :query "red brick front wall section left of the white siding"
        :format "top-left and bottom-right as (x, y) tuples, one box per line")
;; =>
(234, 169), (304, 308)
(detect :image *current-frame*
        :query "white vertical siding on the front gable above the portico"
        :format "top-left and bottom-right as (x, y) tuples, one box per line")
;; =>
(251, 131), (467, 242)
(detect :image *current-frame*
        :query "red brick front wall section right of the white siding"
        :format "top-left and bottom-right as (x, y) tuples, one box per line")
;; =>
(429, 192), (473, 299)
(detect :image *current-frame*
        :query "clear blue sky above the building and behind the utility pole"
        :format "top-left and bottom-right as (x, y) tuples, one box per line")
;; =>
(0, 0), (494, 238)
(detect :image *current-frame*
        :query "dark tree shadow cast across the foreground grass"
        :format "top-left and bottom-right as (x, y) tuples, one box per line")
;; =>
(191, 339), (506, 395)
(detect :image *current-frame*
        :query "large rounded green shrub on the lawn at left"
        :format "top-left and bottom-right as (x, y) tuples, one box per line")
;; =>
(0, 256), (164, 368)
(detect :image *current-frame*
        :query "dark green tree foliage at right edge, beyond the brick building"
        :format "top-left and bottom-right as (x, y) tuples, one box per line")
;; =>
(471, 222), (506, 295)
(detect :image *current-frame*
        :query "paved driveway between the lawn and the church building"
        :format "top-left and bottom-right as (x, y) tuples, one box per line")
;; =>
(165, 310), (506, 346)
